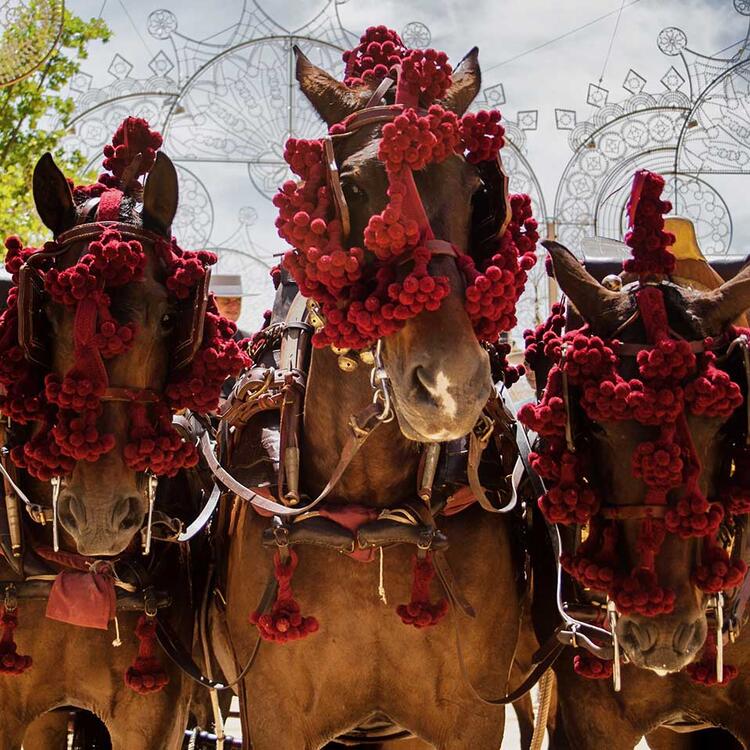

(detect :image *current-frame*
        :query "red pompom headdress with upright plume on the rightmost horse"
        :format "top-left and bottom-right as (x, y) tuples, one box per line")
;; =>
(518, 170), (750, 688)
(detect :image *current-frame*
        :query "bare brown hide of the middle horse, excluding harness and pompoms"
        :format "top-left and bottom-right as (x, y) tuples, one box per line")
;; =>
(212, 51), (520, 750)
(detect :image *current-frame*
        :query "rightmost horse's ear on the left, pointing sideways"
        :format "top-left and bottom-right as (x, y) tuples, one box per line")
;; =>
(542, 240), (623, 333)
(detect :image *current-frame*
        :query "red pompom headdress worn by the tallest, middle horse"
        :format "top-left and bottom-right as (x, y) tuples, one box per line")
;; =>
(274, 26), (538, 349)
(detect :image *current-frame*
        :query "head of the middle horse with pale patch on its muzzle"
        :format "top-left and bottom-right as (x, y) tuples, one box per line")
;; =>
(290, 49), (532, 442)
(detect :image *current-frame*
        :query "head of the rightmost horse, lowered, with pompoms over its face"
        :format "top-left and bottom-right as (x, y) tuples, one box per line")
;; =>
(547, 243), (750, 674)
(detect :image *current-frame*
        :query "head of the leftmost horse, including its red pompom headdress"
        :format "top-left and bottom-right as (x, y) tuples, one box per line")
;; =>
(0, 123), (244, 555)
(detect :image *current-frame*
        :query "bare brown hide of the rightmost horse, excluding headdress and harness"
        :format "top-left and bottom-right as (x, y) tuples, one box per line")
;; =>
(547, 243), (750, 750)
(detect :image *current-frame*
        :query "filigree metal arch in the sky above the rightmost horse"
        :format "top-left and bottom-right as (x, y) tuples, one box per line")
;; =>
(555, 0), (750, 256)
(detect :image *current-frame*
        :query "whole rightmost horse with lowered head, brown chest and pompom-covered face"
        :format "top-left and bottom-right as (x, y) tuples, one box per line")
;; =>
(519, 222), (750, 750)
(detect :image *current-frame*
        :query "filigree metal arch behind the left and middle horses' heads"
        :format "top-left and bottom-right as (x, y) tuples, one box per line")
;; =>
(60, 0), (546, 328)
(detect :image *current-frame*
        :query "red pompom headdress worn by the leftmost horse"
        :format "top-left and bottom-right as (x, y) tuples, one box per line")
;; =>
(0, 117), (253, 480)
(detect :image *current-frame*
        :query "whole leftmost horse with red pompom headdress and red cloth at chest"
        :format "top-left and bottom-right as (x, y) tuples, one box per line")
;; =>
(0, 118), (242, 750)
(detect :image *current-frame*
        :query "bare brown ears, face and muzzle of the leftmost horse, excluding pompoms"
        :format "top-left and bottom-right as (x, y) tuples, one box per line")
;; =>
(29, 154), (177, 555)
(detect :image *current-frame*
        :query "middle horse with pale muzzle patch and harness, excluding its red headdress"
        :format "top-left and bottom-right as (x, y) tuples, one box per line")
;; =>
(210, 27), (540, 750)
